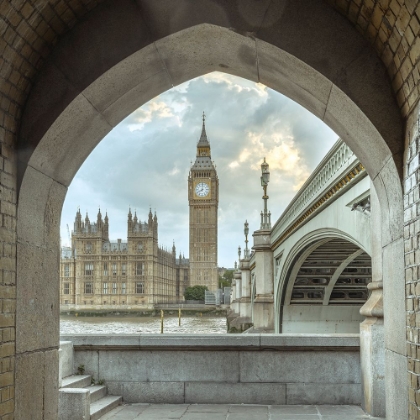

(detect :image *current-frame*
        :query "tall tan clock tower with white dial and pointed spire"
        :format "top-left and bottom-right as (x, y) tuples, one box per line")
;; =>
(188, 112), (219, 291)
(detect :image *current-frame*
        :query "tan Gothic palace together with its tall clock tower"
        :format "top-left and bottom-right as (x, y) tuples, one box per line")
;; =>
(60, 114), (219, 309)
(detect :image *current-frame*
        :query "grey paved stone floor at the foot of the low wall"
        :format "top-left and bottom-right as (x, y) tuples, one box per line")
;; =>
(101, 404), (382, 420)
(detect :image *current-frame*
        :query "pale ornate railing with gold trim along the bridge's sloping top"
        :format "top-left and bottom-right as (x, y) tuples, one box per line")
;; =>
(272, 139), (366, 246)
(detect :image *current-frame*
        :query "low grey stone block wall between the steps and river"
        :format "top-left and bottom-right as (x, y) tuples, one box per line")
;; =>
(61, 334), (361, 404)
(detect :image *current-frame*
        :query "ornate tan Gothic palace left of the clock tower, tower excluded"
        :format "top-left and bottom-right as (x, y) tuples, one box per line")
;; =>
(60, 210), (189, 308)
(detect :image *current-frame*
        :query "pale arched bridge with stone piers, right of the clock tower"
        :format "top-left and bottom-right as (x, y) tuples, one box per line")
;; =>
(229, 140), (392, 414)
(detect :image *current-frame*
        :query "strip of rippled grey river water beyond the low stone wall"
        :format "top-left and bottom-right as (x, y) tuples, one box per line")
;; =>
(60, 315), (226, 335)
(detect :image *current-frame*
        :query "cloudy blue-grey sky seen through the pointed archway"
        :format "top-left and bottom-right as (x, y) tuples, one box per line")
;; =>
(61, 72), (338, 268)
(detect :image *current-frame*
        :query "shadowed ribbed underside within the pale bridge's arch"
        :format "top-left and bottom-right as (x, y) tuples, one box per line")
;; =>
(280, 237), (372, 333)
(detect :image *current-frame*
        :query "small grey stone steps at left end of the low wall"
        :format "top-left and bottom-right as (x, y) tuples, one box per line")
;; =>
(59, 341), (122, 420)
